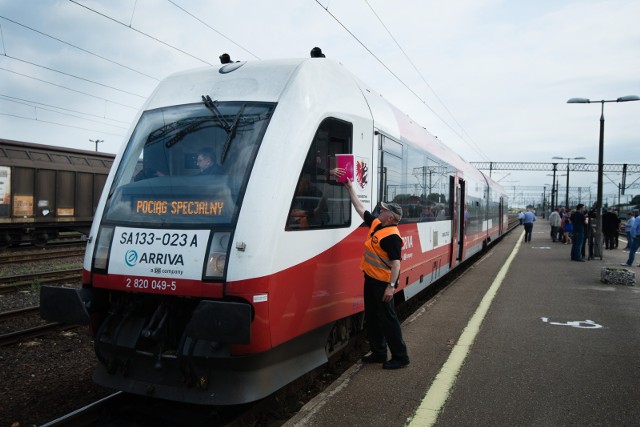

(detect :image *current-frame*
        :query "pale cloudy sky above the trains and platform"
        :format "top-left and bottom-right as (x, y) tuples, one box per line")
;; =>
(0, 0), (640, 206)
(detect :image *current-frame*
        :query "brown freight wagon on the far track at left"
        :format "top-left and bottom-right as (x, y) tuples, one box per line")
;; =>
(0, 139), (115, 248)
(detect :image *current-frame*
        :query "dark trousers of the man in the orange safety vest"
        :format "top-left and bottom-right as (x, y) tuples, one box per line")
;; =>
(364, 274), (409, 362)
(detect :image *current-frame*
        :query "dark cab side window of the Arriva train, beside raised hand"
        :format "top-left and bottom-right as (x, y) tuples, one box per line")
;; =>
(286, 118), (353, 231)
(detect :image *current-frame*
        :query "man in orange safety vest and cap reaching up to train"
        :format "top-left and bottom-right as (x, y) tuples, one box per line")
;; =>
(335, 169), (409, 369)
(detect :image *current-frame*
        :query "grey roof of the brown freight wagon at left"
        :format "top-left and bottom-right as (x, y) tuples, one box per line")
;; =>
(0, 139), (115, 174)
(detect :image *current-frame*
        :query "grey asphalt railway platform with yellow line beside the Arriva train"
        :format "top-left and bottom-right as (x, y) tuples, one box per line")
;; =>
(286, 226), (640, 427)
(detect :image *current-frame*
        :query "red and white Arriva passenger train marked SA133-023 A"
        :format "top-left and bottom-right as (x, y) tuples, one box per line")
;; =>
(41, 58), (508, 405)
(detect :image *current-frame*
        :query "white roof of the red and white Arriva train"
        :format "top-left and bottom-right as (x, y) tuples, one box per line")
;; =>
(143, 58), (500, 194)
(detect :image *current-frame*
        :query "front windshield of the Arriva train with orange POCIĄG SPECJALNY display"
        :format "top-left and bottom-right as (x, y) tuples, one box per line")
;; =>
(104, 102), (275, 227)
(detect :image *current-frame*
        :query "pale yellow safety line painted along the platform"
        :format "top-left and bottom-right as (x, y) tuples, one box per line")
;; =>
(408, 232), (524, 427)
